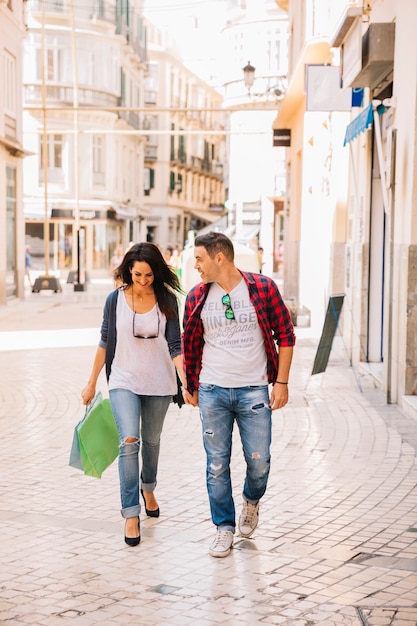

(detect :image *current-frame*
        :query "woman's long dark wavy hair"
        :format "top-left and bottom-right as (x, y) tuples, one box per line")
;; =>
(114, 242), (185, 319)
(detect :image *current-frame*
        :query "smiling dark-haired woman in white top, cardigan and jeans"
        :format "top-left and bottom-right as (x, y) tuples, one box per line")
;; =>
(81, 243), (185, 546)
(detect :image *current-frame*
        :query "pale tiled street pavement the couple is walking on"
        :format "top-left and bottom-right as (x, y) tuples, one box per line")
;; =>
(0, 280), (417, 626)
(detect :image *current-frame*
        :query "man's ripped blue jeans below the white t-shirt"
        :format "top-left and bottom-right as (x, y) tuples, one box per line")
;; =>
(198, 383), (272, 532)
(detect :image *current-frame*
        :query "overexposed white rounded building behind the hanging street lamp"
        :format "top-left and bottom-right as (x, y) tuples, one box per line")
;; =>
(221, 0), (288, 275)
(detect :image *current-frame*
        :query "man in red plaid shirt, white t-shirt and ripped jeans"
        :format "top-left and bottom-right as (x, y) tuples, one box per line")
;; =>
(183, 232), (295, 557)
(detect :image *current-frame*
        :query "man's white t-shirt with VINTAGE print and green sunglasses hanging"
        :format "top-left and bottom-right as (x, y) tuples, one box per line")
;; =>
(200, 278), (268, 387)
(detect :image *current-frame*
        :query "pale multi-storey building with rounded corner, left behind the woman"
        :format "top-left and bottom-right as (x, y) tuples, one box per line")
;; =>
(24, 0), (146, 279)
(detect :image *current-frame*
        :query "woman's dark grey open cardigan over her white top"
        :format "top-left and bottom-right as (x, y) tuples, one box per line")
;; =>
(99, 288), (182, 382)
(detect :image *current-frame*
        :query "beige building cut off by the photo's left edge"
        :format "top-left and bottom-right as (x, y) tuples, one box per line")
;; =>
(0, 0), (26, 305)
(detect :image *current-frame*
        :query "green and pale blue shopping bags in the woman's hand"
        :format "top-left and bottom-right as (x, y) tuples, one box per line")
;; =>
(70, 392), (119, 478)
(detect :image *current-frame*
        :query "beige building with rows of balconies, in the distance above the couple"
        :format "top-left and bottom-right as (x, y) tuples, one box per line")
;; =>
(145, 24), (226, 250)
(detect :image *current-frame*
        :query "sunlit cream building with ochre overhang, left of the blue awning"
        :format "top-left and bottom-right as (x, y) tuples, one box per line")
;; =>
(273, 0), (351, 334)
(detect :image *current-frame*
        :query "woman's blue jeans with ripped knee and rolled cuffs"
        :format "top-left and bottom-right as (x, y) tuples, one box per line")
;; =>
(109, 389), (172, 517)
